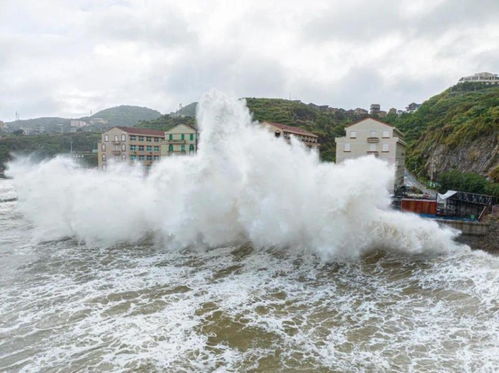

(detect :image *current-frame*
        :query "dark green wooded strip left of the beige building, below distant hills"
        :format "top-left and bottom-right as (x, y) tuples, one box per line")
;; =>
(0, 132), (101, 170)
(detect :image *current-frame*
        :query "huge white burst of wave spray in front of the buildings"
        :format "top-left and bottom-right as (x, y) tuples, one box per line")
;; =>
(8, 91), (466, 259)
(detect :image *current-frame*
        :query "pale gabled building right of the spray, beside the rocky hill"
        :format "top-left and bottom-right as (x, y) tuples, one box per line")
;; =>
(335, 118), (406, 190)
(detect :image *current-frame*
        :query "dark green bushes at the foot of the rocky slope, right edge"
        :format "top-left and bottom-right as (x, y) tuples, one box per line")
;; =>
(438, 170), (499, 197)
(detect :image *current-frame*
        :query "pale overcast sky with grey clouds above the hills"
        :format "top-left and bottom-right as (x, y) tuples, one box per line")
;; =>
(0, 0), (499, 121)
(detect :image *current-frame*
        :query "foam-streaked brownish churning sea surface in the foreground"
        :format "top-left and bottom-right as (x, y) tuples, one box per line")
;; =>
(0, 180), (499, 372)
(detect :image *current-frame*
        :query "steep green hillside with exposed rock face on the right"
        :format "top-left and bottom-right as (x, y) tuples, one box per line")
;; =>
(392, 83), (499, 179)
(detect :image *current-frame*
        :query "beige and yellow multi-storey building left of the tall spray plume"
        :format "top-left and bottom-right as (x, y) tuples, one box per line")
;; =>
(97, 124), (199, 169)
